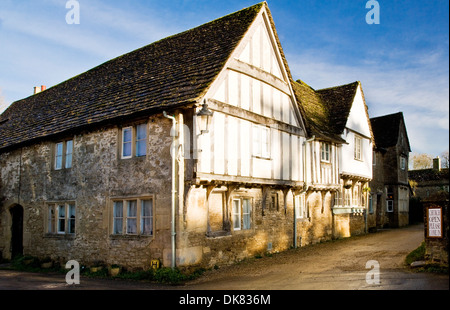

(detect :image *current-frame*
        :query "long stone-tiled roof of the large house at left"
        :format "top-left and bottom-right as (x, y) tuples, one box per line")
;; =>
(0, 2), (265, 150)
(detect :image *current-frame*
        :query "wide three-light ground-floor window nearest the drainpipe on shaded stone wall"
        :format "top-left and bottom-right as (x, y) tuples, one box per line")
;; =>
(112, 198), (153, 236)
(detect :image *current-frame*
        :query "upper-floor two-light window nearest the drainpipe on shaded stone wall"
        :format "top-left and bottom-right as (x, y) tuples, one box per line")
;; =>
(121, 124), (147, 159)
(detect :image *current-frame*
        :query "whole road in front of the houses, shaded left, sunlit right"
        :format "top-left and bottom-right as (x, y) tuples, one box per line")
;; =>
(0, 225), (449, 290)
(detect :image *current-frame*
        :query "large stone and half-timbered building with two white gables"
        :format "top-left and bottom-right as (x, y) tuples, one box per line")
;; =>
(0, 2), (373, 268)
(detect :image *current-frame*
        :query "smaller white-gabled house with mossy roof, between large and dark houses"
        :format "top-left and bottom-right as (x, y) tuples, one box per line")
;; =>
(293, 80), (373, 237)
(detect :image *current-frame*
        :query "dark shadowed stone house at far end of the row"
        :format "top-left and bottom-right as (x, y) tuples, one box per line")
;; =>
(368, 112), (411, 229)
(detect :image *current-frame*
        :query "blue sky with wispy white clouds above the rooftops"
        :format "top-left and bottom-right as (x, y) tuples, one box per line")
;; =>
(0, 0), (449, 156)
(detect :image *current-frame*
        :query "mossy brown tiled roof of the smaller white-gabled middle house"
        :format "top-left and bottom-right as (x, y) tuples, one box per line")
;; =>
(292, 80), (359, 142)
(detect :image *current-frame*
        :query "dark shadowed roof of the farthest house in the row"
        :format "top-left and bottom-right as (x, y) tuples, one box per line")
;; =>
(370, 112), (409, 148)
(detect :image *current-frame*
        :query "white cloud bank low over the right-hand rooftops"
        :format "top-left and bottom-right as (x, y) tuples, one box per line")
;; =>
(287, 47), (449, 154)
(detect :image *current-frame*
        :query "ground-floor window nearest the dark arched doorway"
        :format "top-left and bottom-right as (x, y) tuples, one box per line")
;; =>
(47, 203), (76, 234)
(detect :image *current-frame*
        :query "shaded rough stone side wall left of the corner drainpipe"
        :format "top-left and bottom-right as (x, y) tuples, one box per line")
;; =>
(0, 116), (171, 268)
